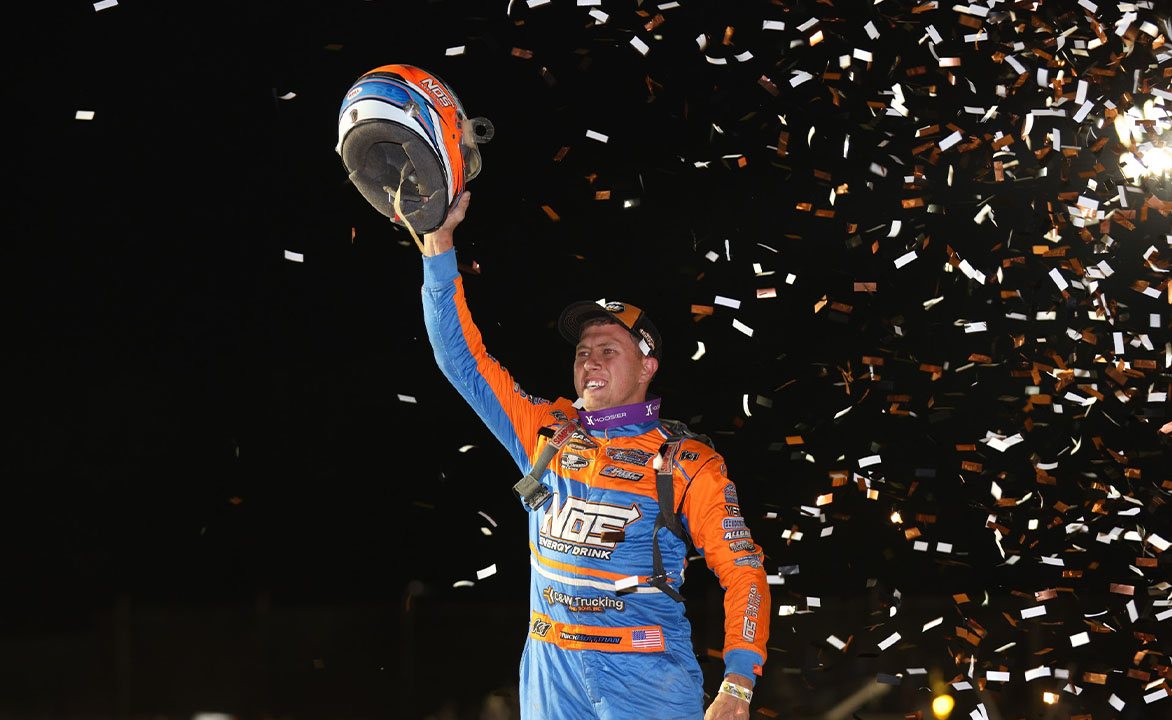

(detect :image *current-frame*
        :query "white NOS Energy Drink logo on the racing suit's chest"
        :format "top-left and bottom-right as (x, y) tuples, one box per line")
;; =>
(538, 493), (642, 561)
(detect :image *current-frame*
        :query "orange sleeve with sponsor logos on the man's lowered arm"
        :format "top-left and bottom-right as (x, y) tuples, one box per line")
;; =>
(683, 454), (770, 681)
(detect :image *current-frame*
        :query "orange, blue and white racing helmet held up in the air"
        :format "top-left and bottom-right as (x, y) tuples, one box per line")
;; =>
(334, 64), (493, 233)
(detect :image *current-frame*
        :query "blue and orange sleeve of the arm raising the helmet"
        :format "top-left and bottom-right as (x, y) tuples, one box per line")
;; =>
(423, 249), (550, 473)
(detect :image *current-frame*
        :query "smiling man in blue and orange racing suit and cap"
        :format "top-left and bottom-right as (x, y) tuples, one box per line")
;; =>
(423, 192), (770, 720)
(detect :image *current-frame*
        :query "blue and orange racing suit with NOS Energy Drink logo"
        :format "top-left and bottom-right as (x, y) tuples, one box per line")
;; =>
(423, 250), (770, 720)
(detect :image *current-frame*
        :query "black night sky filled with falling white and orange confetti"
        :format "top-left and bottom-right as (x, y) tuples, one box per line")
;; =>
(0, 0), (1172, 720)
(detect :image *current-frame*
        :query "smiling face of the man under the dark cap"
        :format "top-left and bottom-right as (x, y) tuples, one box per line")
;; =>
(574, 322), (659, 410)
